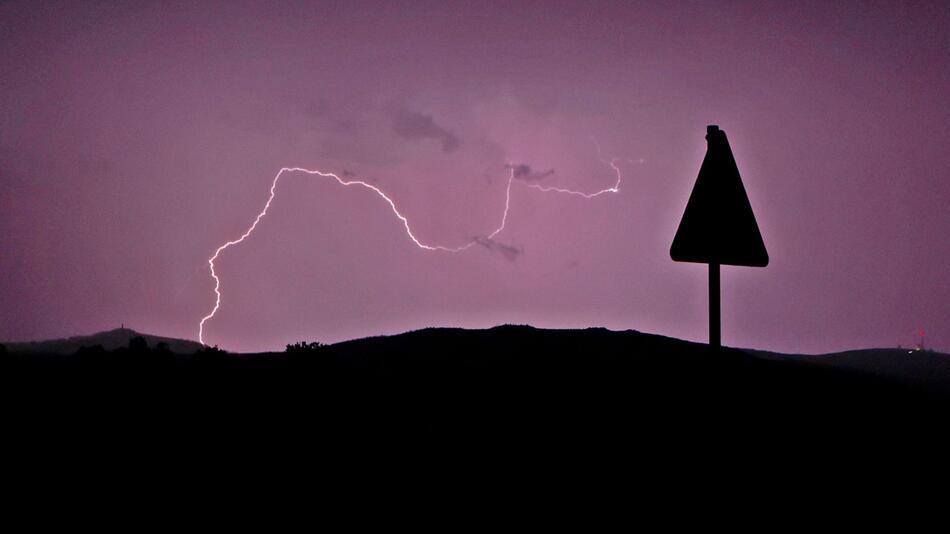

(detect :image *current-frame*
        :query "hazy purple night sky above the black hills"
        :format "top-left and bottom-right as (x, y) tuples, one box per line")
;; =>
(0, 1), (950, 352)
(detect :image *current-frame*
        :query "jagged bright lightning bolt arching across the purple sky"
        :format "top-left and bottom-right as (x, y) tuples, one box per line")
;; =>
(198, 155), (623, 345)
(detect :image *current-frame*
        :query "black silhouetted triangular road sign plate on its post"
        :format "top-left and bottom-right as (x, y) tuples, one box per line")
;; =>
(670, 126), (769, 267)
